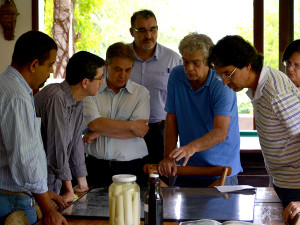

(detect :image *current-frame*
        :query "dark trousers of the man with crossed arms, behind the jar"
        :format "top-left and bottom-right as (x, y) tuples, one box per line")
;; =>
(85, 155), (147, 187)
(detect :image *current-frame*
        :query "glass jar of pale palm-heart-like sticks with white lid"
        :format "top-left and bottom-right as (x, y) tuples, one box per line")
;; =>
(108, 174), (141, 225)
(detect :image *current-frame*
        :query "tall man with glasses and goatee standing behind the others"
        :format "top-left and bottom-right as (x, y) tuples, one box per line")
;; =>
(130, 10), (182, 166)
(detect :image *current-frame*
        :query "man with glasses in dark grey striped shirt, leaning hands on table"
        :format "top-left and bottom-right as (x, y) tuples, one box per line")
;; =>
(34, 51), (104, 202)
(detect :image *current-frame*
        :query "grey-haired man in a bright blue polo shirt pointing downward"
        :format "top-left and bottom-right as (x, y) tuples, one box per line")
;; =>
(159, 33), (242, 187)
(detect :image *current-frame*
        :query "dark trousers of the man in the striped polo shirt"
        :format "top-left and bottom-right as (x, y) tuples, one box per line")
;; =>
(273, 184), (300, 207)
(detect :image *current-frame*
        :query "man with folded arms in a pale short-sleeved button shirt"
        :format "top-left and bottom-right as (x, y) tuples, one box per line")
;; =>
(83, 42), (150, 185)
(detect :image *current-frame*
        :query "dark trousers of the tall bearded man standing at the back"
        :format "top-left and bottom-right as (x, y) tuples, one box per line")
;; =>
(144, 120), (165, 164)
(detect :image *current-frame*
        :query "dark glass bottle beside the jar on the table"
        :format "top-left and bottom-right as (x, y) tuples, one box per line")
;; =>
(144, 174), (163, 225)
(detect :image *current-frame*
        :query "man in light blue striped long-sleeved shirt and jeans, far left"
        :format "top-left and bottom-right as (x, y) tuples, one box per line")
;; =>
(0, 31), (67, 224)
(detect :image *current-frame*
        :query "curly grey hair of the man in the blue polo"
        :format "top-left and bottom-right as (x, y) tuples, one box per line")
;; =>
(178, 32), (214, 63)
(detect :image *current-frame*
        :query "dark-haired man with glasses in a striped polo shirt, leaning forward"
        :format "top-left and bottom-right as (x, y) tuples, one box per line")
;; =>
(209, 36), (300, 221)
